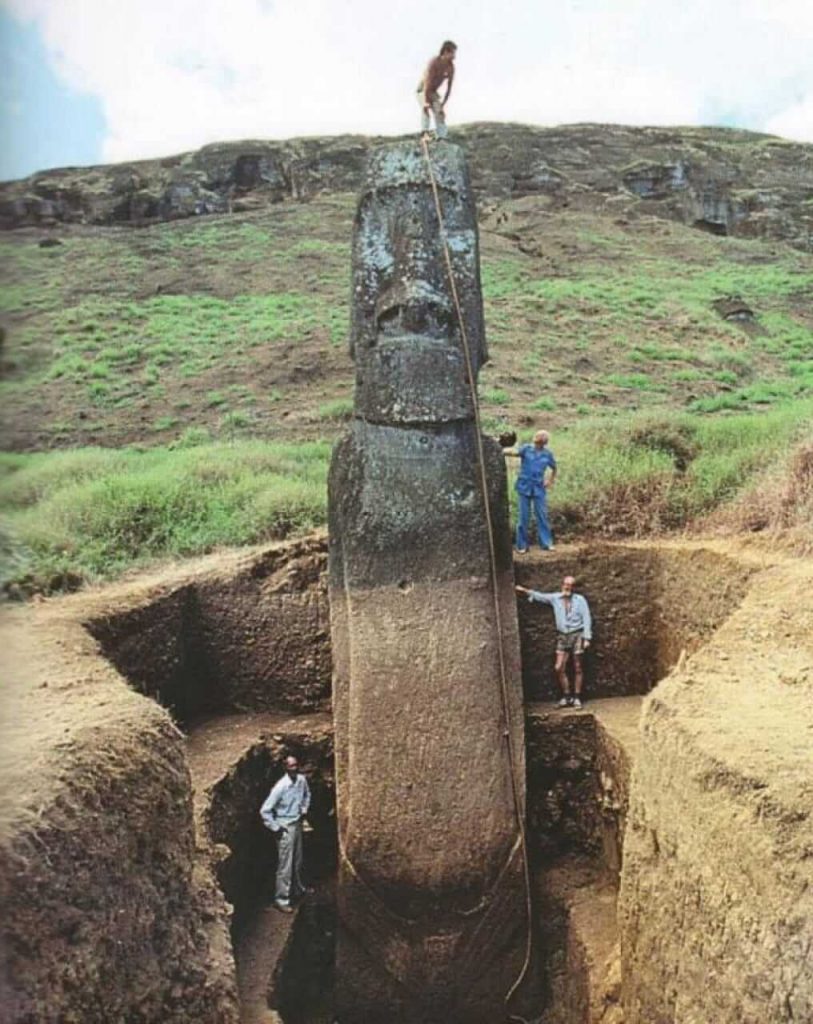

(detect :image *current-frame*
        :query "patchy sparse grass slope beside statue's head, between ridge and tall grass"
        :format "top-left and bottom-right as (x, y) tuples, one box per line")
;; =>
(0, 196), (813, 446)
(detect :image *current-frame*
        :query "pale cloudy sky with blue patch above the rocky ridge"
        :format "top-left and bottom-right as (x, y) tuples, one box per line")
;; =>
(0, 0), (813, 179)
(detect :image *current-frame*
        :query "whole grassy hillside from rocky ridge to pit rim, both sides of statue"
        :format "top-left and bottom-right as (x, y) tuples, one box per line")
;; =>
(0, 124), (813, 592)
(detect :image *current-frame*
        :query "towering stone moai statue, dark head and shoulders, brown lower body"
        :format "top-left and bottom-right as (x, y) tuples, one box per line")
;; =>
(329, 142), (528, 1024)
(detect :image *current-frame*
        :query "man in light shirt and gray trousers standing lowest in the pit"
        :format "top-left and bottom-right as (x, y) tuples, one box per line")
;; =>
(260, 757), (310, 913)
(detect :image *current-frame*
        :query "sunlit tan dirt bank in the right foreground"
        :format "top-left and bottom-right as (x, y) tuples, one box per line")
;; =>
(619, 559), (813, 1024)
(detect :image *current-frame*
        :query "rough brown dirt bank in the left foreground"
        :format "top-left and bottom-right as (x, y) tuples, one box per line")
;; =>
(0, 608), (239, 1024)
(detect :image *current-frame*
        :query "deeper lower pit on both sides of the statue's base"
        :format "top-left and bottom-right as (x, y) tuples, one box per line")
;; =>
(188, 696), (640, 1024)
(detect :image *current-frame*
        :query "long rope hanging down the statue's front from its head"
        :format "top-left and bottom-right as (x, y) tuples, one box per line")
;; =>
(421, 135), (531, 1005)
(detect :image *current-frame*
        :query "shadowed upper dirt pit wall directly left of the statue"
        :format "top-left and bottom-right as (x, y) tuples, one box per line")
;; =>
(85, 537), (332, 726)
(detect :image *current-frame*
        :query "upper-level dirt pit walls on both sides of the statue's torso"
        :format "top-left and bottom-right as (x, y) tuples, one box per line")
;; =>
(85, 535), (754, 727)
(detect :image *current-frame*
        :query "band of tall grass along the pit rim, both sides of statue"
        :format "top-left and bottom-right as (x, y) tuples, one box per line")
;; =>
(0, 399), (813, 588)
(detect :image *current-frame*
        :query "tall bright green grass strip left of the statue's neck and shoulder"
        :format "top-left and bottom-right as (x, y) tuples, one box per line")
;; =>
(0, 442), (330, 593)
